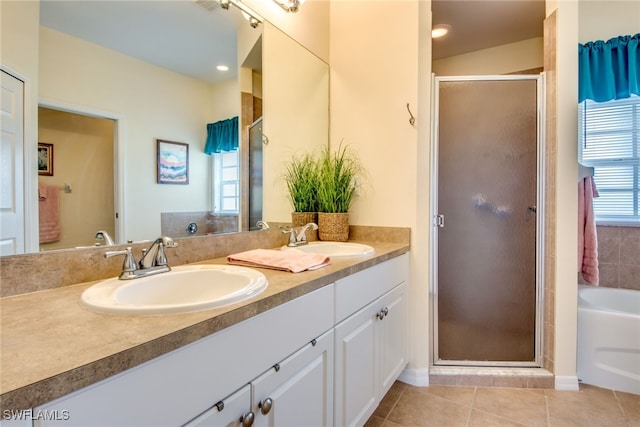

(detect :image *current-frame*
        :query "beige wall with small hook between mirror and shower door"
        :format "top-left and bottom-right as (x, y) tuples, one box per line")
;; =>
(330, 0), (431, 383)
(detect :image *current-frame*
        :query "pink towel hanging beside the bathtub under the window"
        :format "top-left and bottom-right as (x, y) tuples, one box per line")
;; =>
(578, 176), (599, 285)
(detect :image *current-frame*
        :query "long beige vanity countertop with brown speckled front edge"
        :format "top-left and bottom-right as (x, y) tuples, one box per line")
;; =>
(0, 241), (409, 411)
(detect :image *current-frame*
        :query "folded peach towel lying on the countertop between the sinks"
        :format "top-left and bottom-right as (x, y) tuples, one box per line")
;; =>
(227, 249), (331, 273)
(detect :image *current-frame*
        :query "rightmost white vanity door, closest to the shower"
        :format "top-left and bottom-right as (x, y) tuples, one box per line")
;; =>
(378, 283), (407, 396)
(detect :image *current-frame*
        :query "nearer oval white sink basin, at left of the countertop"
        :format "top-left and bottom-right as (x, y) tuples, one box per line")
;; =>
(80, 264), (267, 314)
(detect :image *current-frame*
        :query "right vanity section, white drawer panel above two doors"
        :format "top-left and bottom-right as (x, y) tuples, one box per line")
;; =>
(334, 255), (408, 426)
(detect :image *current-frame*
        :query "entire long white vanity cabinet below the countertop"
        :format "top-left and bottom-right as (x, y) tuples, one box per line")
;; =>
(27, 254), (409, 427)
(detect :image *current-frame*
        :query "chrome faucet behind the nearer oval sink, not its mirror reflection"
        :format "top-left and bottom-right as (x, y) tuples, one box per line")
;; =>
(104, 236), (178, 280)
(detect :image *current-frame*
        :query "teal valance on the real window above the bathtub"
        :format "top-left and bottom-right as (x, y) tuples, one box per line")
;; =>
(578, 33), (640, 102)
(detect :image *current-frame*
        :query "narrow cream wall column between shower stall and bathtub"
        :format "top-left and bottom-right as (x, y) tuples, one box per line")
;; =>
(547, 0), (578, 389)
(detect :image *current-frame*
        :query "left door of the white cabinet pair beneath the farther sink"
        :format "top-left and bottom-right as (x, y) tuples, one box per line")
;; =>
(334, 302), (381, 427)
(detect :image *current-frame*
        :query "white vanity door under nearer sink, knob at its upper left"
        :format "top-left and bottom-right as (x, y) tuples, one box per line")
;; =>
(252, 331), (333, 427)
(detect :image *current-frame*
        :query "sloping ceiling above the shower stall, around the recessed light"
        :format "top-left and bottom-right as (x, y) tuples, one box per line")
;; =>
(431, 0), (545, 60)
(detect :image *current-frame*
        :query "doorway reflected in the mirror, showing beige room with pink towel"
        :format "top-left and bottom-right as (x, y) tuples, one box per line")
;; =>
(38, 107), (116, 250)
